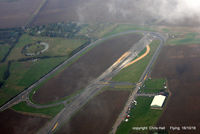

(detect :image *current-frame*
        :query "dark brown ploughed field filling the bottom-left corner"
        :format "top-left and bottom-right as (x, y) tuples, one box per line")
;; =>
(0, 109), (48, 134)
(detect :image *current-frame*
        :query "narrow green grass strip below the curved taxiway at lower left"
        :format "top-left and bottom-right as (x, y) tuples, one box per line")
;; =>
(12, 102), (64, 117)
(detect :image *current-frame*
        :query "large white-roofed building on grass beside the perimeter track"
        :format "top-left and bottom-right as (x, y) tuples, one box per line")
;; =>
(151, 95), (166, 108)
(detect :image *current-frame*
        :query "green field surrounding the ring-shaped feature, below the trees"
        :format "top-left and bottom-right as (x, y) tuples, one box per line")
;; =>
(7, 34), (86, 60)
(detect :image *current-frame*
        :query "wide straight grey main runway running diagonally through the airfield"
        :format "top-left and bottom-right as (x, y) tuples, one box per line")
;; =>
(38, 31), (156, 134)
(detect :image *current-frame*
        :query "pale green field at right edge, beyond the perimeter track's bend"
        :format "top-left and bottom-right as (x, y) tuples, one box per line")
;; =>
(167, 33), (200, 45)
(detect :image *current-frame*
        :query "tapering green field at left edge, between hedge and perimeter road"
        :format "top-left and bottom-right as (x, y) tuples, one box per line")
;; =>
(0, 57), (66, 105)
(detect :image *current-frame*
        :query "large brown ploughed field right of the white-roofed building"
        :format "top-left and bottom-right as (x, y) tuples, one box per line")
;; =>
(152, 45), (200, 134)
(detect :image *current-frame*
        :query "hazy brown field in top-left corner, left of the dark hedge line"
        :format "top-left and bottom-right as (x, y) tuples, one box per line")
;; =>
(0, 0), (41, 28)
